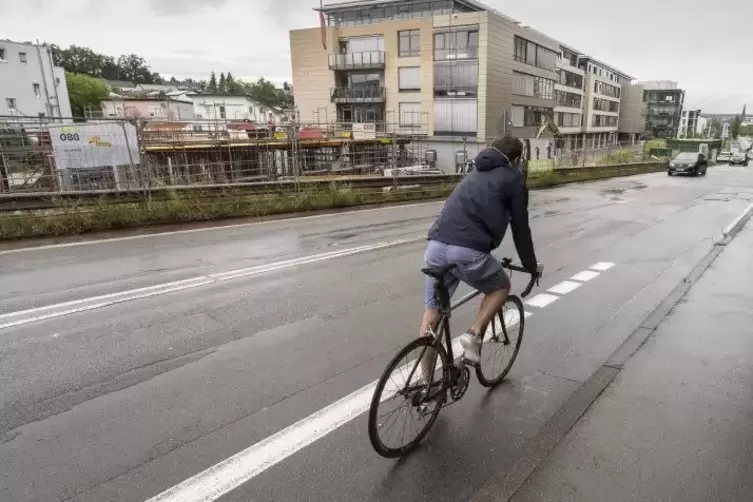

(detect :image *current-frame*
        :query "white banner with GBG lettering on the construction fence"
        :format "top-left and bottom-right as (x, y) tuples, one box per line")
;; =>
(50, 122), (139, 169)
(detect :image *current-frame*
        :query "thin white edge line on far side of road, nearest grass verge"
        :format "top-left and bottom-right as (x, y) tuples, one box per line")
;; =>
(0, 201), (444, 255)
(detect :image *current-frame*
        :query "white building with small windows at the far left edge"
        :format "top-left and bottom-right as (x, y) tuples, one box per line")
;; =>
(0, 40), (72, 120)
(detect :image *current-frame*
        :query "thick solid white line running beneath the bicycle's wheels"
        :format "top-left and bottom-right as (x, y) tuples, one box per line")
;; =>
(147, 311), (531, 502)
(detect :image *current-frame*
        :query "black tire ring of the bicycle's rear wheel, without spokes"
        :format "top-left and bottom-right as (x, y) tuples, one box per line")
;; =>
(368, 337), (450, 458)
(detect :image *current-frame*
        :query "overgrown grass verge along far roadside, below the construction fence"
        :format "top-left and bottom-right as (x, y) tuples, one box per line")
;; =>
(0, 164), (664, 240)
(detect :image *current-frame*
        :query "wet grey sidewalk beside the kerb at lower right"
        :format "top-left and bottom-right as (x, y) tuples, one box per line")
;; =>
(512, 221), (753, 502)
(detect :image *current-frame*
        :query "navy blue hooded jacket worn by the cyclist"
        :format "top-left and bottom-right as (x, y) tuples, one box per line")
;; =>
(428, 148), (537, 272)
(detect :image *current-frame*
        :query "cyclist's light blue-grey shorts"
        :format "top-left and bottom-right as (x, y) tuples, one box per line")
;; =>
(424, 237), (510, 308)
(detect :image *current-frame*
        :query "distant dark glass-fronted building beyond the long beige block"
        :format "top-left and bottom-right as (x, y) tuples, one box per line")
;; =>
(639, 80), (685, 138)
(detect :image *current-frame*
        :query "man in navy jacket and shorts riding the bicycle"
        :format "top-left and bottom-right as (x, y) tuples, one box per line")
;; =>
(419, 135), (540, 370)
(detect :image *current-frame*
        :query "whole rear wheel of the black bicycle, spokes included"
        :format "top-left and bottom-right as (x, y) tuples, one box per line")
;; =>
(369, 337), (450, 458)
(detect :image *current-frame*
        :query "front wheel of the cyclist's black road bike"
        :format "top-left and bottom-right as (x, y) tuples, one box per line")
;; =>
(476, 295), (526, 387)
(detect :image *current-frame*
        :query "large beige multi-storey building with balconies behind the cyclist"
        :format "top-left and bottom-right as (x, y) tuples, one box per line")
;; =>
(290, 0), (630, 171)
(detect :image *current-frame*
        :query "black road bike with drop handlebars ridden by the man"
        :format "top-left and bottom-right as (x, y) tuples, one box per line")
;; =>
(368, 258), (541, 458)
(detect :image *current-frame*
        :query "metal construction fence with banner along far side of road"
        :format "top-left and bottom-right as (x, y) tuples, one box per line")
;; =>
(0, 115), (428, 193)
